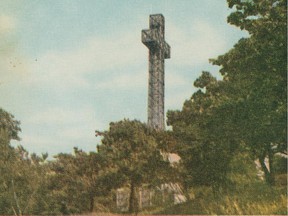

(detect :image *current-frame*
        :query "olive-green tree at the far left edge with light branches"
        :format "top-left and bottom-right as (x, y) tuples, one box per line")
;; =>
(0, 109), (48, 215)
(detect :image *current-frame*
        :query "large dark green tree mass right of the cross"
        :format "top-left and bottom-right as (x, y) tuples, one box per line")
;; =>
(168, 0), (287, 188)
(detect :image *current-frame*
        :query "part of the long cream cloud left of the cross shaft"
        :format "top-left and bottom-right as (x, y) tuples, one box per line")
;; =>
(22, 29), (146, 90)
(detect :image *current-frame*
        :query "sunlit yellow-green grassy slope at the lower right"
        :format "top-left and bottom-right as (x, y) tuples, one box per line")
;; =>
(153, 183), (287, 215)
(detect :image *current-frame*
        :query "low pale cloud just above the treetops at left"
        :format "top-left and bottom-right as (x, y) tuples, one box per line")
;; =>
(21, 107), (104, 156)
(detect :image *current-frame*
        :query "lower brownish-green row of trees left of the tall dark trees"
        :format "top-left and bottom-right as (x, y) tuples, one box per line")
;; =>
(0, 112), (177, 215)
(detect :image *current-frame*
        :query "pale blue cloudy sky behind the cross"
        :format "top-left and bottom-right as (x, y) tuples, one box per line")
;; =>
(0, 0), (247, 157)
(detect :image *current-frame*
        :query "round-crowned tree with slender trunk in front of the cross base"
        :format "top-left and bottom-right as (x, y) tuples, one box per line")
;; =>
(98, 120), (170, 212)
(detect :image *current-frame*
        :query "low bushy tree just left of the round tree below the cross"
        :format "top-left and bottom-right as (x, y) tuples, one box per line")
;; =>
(48, 148), (112, 214)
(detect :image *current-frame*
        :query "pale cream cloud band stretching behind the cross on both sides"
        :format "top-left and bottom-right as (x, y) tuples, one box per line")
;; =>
(20, 17), (226, 93)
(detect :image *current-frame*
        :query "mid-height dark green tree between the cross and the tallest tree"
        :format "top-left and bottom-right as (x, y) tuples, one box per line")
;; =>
(167, 72), (237, 192)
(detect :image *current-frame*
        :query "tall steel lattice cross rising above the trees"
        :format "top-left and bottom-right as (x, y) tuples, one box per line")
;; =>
(142, 14), (170, 130)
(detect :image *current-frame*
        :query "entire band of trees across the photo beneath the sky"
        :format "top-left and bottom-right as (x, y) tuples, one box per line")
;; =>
(0, 0), (287, 215)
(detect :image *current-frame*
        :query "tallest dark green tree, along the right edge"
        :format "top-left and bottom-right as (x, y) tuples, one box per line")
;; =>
(212, 0), (287, 184)
